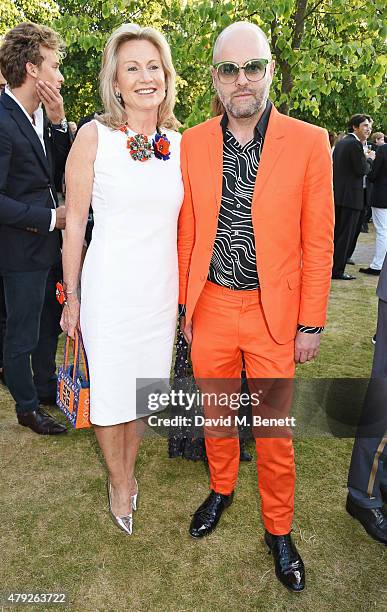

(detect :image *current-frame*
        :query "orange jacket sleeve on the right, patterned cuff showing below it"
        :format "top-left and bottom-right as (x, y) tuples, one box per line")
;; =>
(298, 130), (334, 327)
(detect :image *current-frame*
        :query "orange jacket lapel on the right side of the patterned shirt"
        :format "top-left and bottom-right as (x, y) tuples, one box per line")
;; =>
(252, 106), (284, 206)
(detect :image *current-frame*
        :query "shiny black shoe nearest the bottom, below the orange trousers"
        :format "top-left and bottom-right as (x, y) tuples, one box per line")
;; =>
(265, 531), (305, 593)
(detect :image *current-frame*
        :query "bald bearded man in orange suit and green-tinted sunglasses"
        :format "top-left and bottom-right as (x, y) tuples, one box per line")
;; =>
(178, 22), (333, 591)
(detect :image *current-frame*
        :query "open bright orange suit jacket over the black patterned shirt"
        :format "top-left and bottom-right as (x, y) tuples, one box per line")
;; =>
(178, 107), (334, 344)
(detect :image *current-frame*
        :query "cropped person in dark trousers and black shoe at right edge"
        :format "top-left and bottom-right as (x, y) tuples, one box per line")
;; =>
(346, 255), (387, 544)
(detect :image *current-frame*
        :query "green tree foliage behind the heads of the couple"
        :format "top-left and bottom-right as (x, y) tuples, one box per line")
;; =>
(2, 0), (387, 130)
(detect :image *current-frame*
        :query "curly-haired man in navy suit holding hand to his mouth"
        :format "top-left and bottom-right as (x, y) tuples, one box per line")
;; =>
(0, 23), (70, 435)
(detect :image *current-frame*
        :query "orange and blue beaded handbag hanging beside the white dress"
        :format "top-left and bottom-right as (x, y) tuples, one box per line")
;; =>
(56, 329), (91, 429)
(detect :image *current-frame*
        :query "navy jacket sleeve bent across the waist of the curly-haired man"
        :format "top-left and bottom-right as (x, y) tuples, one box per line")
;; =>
(0, 127), (51, 234)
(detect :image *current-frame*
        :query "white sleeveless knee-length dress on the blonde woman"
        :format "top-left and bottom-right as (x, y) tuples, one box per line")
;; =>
(80, 121), (183, 426)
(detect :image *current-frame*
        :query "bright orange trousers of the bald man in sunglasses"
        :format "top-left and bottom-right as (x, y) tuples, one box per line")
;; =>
(191, 282), (296, 535)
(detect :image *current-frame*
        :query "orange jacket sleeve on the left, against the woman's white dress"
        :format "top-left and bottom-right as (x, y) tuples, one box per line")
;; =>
(177, 134), (195, 305)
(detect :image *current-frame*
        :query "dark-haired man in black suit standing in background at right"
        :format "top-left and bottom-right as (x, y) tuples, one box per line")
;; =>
(332, 115), (375, 280)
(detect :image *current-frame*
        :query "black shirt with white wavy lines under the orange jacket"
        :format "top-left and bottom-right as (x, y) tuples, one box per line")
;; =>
(179, 100), (324, 334)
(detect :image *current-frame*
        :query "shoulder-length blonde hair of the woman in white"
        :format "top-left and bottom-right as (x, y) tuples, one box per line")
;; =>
(96, 23), (180, 130)
